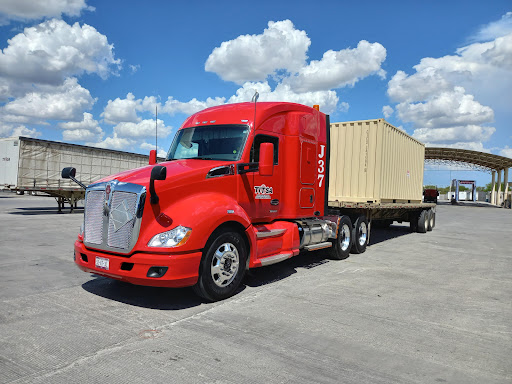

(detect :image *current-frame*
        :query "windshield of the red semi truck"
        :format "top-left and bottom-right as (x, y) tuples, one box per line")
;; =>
(166, 125), (249, 160)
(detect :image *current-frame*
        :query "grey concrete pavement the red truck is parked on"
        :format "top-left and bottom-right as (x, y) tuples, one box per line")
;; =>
(0, 193), (512, 384)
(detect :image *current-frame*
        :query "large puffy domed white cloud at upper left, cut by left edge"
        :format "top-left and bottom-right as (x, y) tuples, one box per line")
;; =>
(0, 19), (120, 91)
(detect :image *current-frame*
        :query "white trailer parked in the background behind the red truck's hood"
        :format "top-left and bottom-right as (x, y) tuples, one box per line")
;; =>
(0, 136), (156, 211)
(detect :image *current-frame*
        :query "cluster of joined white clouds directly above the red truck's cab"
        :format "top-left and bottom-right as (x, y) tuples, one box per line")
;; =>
(202, 20), (386, 114)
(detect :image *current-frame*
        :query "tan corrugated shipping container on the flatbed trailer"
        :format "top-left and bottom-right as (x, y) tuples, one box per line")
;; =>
(329, 119), (425, 206)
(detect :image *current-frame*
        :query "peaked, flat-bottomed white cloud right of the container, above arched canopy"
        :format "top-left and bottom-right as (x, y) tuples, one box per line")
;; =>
(396, 87), (494, 128)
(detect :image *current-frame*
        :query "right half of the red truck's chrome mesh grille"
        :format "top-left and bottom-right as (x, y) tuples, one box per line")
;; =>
(107, 192), (137, 249)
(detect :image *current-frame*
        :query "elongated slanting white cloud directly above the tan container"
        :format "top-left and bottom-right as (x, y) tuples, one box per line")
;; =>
(285, 40), (386, 92)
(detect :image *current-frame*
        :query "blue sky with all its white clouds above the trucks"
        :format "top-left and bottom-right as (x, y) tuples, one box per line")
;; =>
(0, 0), (512, 185)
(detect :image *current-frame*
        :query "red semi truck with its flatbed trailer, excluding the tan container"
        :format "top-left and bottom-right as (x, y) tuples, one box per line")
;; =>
(62, 102), (435, 301)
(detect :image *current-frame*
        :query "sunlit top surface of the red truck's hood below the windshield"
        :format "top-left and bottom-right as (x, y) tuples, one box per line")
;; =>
(97, 159), (232, 189)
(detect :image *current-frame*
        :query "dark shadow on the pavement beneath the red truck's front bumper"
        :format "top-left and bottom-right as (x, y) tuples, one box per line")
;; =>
(82, 276), (203, 311)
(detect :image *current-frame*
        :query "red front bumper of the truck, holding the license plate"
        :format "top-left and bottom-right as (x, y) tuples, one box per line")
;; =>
(75, 240), (202, 287)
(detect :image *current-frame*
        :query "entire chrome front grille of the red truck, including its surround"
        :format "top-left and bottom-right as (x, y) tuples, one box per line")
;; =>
(84, 180), (146, 254)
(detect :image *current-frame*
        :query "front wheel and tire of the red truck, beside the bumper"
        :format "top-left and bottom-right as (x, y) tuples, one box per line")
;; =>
(194, 232), (247, 301)
